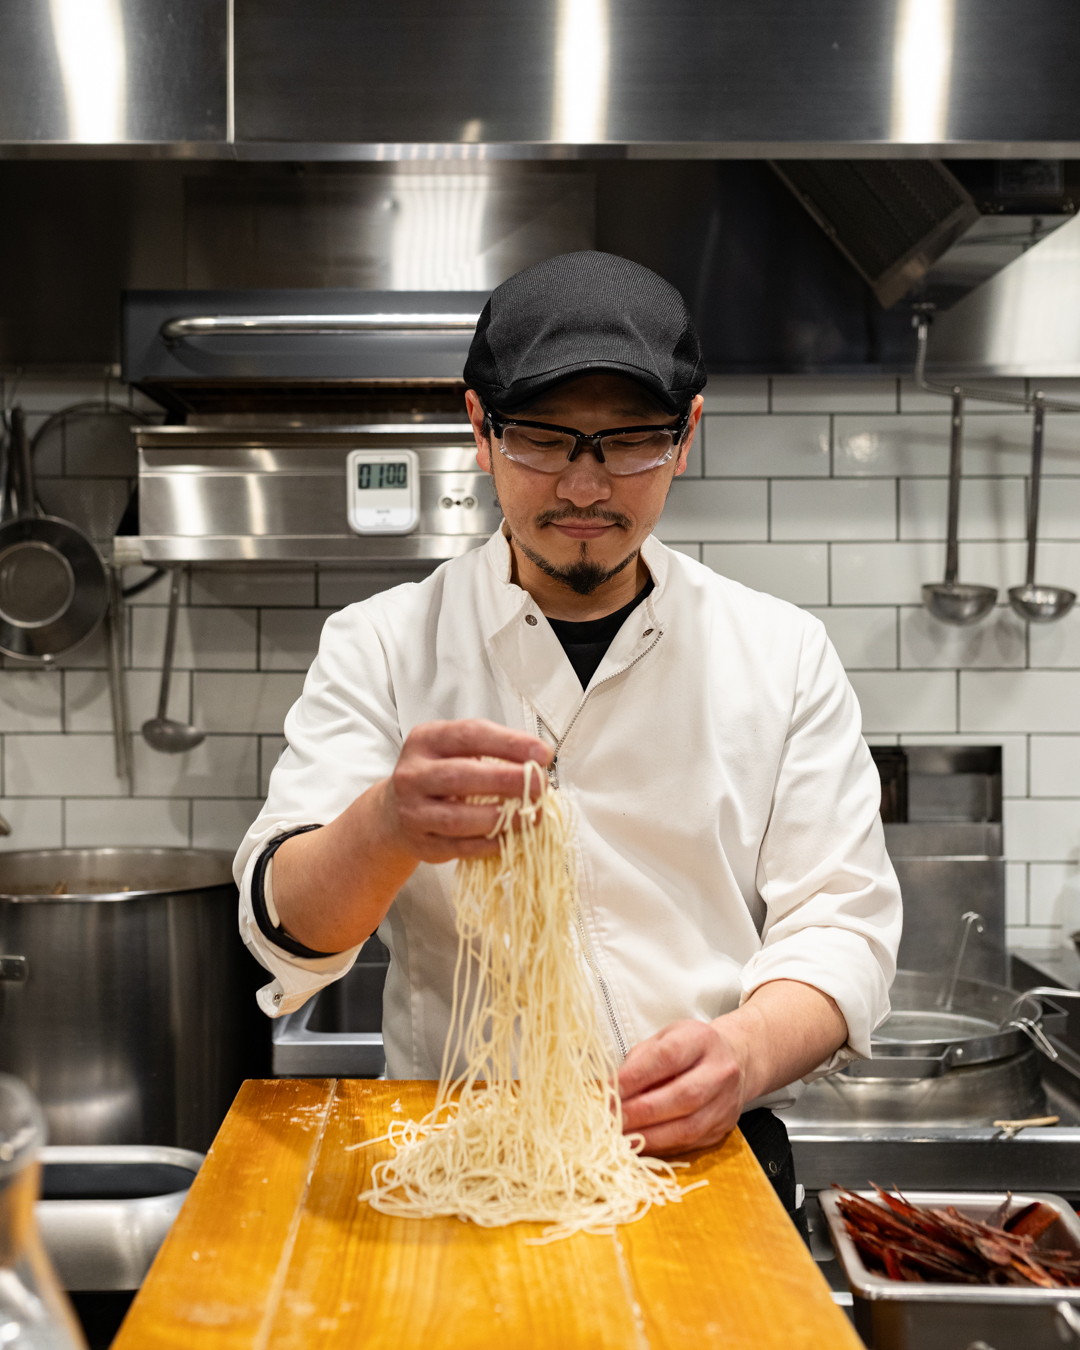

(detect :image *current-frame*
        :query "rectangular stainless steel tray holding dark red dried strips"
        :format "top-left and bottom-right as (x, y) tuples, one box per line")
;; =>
(818, 1191), (1080, 1350)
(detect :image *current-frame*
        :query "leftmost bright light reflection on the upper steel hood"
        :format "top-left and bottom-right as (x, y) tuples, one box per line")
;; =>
(49, 0), (127, 144)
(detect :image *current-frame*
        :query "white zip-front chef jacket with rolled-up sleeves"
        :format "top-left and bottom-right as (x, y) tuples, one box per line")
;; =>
(234, 532), (900, 1106)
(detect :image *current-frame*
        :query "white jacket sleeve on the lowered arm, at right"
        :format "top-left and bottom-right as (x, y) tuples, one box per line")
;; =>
(743, 621), (902, 1081)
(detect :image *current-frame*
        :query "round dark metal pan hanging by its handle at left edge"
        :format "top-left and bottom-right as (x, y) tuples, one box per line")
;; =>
(0, 408), (108, 663)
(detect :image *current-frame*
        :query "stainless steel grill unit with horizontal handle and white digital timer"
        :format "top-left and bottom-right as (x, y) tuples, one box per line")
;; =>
(113, 290), (502, 566)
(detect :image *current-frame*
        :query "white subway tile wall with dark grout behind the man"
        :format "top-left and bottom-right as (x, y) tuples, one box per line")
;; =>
(0, 377), (1080, 941)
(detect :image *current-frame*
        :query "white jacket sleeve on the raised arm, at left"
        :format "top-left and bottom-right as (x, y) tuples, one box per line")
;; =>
(232, 605), (401, 1017)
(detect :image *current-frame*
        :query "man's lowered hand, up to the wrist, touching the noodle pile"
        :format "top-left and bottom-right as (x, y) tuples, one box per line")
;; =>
(618, 1022), (745, 1154)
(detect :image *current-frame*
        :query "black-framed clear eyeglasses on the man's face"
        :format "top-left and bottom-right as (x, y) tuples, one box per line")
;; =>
(485, 409), (690, 477)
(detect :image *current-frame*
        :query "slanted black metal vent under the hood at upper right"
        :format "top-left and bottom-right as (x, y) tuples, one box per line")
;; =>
(772, 159), (979, 309)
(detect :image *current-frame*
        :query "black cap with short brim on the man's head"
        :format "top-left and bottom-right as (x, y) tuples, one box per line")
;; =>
(464, 252), (706, 413)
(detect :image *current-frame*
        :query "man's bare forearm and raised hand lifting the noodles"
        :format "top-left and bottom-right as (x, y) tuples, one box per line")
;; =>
(274, 720), (551, 952)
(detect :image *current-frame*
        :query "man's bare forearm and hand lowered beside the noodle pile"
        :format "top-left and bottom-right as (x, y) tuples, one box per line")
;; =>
(618, 980), (848, 1153)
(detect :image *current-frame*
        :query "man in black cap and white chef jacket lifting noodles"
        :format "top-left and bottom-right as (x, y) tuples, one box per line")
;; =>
(236, 252), (900, 1231)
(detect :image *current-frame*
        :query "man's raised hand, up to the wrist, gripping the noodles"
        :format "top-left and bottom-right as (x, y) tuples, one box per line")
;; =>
(373, 720), (551, 863)
